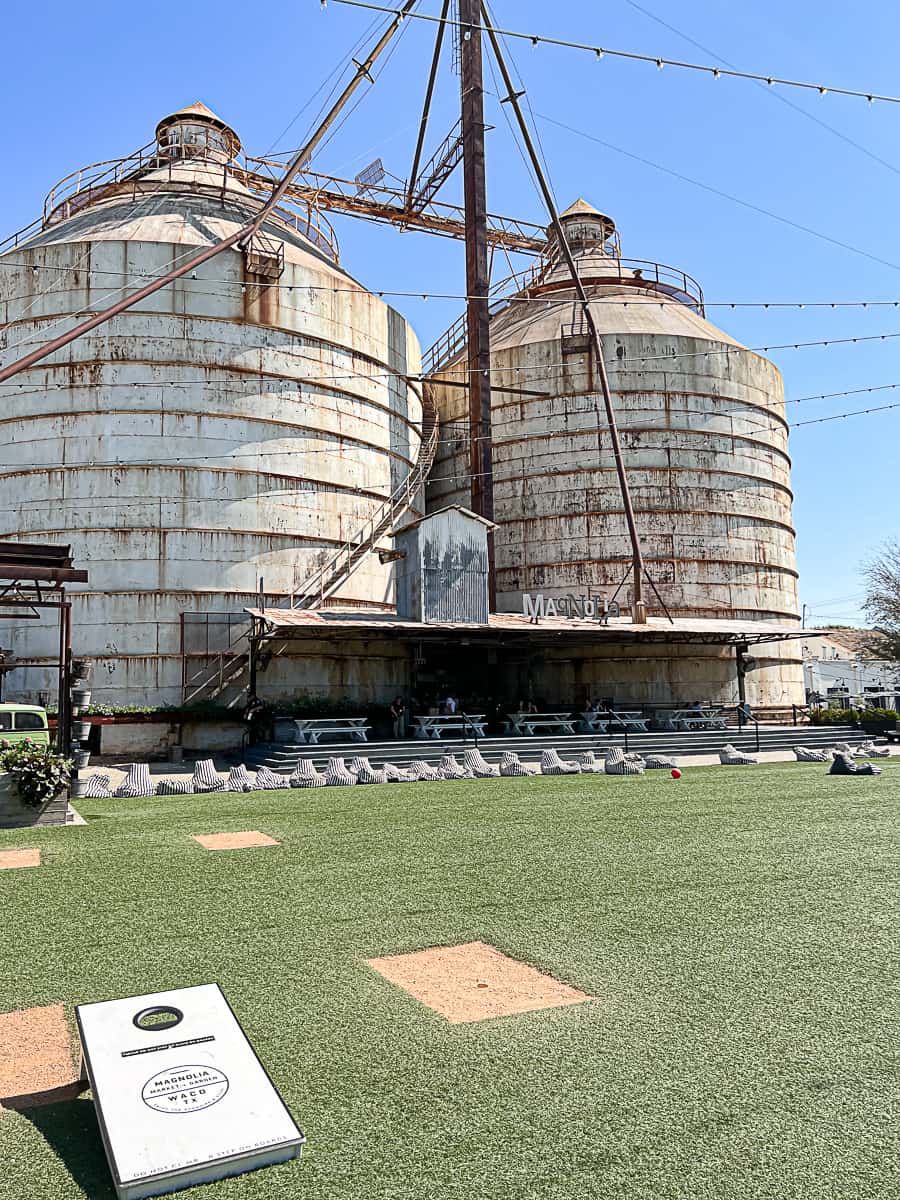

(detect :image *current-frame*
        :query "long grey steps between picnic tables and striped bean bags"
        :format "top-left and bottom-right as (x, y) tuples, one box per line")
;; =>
(244, 725), (865, 772)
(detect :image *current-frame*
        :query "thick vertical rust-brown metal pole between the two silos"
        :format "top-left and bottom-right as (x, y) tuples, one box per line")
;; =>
(460, 0), (497, 611)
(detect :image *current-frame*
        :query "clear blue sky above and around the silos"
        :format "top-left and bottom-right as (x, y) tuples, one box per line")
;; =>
(0, 0), (900, 623)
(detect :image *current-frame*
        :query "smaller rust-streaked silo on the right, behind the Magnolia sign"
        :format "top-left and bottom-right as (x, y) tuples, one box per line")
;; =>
(426, 200), (804, 707)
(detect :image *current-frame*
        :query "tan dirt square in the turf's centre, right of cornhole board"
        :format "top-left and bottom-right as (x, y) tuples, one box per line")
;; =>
(368, 942), (593, 1025)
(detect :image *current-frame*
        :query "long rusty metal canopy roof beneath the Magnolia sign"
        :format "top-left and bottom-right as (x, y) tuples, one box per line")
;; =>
(245, 608), (815, 646)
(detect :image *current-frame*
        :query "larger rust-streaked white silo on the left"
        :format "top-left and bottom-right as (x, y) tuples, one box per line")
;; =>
(0, 104), (422, 704)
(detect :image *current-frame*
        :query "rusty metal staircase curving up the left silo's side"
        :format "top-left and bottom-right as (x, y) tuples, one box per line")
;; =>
(181, 392), (438, 708)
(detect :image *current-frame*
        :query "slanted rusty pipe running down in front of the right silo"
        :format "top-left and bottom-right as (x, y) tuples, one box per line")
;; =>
(479, 9), (647, 625)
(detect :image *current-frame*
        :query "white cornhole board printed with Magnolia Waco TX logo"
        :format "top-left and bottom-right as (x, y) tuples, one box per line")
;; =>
(76, 983), (306, 1200)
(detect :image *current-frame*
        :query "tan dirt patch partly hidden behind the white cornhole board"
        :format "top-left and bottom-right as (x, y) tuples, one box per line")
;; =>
(0, 1004), (86, 1109)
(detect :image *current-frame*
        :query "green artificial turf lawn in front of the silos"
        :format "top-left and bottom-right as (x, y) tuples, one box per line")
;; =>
(0, 763), (900, 1200)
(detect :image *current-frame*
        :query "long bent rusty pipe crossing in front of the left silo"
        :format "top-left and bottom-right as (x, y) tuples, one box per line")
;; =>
(0, 0), (419, 383)
